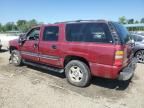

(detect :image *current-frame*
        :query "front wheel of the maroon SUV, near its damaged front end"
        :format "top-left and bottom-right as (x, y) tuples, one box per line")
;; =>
(10, 50), (22, 66)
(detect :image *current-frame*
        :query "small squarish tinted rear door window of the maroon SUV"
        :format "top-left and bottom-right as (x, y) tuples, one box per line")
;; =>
(43, 26), (59, 41)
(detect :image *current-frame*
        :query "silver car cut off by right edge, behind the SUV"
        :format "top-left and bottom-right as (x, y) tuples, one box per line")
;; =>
(131, 34), (144, 63)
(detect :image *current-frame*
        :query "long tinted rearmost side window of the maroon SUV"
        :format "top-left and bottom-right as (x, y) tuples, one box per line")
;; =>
(66, 23), (112, 43)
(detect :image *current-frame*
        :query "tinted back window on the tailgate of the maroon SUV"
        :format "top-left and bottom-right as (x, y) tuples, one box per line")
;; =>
(113, 22), (132, 43)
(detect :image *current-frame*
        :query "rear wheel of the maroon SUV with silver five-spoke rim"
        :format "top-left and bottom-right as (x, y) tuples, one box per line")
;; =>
(65, 60), (91, 87)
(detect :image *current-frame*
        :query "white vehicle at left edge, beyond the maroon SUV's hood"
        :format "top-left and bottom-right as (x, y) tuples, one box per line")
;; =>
(0, 34), (19, 49)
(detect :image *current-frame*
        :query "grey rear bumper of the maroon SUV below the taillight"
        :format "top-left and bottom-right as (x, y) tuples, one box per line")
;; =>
(118, 58), (137, 81)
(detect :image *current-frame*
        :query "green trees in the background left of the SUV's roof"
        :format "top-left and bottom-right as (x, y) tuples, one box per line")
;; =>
(0, 19), (42, 33)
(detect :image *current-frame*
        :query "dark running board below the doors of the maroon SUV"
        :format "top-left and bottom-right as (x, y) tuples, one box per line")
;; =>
(23, 60), (64, 73)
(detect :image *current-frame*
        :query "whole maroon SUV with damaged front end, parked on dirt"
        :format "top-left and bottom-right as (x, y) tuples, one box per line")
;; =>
(9, 20), (136, 87)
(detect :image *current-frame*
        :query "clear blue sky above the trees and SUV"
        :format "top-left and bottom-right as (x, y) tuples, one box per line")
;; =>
(0, 0), (144, 24)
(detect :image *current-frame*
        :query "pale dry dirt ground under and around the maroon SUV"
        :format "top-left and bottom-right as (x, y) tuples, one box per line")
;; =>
(0, 51), (144, 108)
